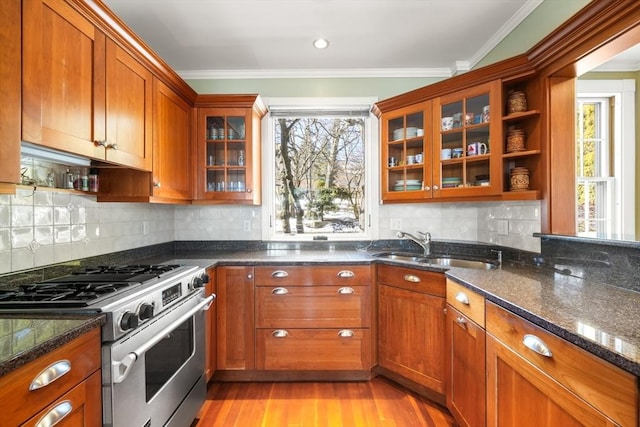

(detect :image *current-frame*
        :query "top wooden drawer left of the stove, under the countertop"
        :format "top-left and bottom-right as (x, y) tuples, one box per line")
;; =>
(0, 328), (100, 425)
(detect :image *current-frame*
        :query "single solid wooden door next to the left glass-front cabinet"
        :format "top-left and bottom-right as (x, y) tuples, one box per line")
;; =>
(152, 79), (193, 200)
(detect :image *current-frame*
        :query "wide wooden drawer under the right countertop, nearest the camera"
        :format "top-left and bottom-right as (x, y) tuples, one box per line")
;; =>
(486, 302), (638, 426)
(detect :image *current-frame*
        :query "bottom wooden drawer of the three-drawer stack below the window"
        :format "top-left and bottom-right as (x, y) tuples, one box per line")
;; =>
(256, 329), (371, 371)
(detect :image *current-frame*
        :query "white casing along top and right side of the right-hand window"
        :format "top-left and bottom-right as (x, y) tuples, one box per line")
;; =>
(576, 79), (636, 236)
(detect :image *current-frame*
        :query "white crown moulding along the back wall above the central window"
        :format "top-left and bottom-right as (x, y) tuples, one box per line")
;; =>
(177, 68), (453, 80)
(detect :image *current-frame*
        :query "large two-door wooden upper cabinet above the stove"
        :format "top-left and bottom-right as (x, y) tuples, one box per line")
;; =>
(22, 0), (152, 170)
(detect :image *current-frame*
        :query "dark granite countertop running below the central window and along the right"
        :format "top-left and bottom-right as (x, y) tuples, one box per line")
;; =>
(140, 249), (640, 376)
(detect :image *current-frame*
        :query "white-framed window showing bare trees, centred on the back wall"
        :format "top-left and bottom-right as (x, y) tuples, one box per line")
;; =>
(263, 98), (378, 240)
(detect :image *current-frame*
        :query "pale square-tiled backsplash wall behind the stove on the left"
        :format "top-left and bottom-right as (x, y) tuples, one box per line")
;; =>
(0, 190), (175, 274)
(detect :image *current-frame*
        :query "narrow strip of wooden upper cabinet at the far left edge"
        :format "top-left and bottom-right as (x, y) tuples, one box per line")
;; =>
(0, 0), (22, 194)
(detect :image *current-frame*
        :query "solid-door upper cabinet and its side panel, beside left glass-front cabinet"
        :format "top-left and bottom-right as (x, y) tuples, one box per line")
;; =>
(98, 77), (194, 204)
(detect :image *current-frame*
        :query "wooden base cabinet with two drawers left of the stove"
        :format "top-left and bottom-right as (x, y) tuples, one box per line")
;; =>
(0, 328), (102, 427)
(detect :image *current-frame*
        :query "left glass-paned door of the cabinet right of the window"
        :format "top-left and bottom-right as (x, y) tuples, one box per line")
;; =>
(381, 101), (431, 201)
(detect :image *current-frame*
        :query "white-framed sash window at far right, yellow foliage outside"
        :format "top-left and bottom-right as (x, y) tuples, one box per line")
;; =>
(576, 80), (635, 237)
